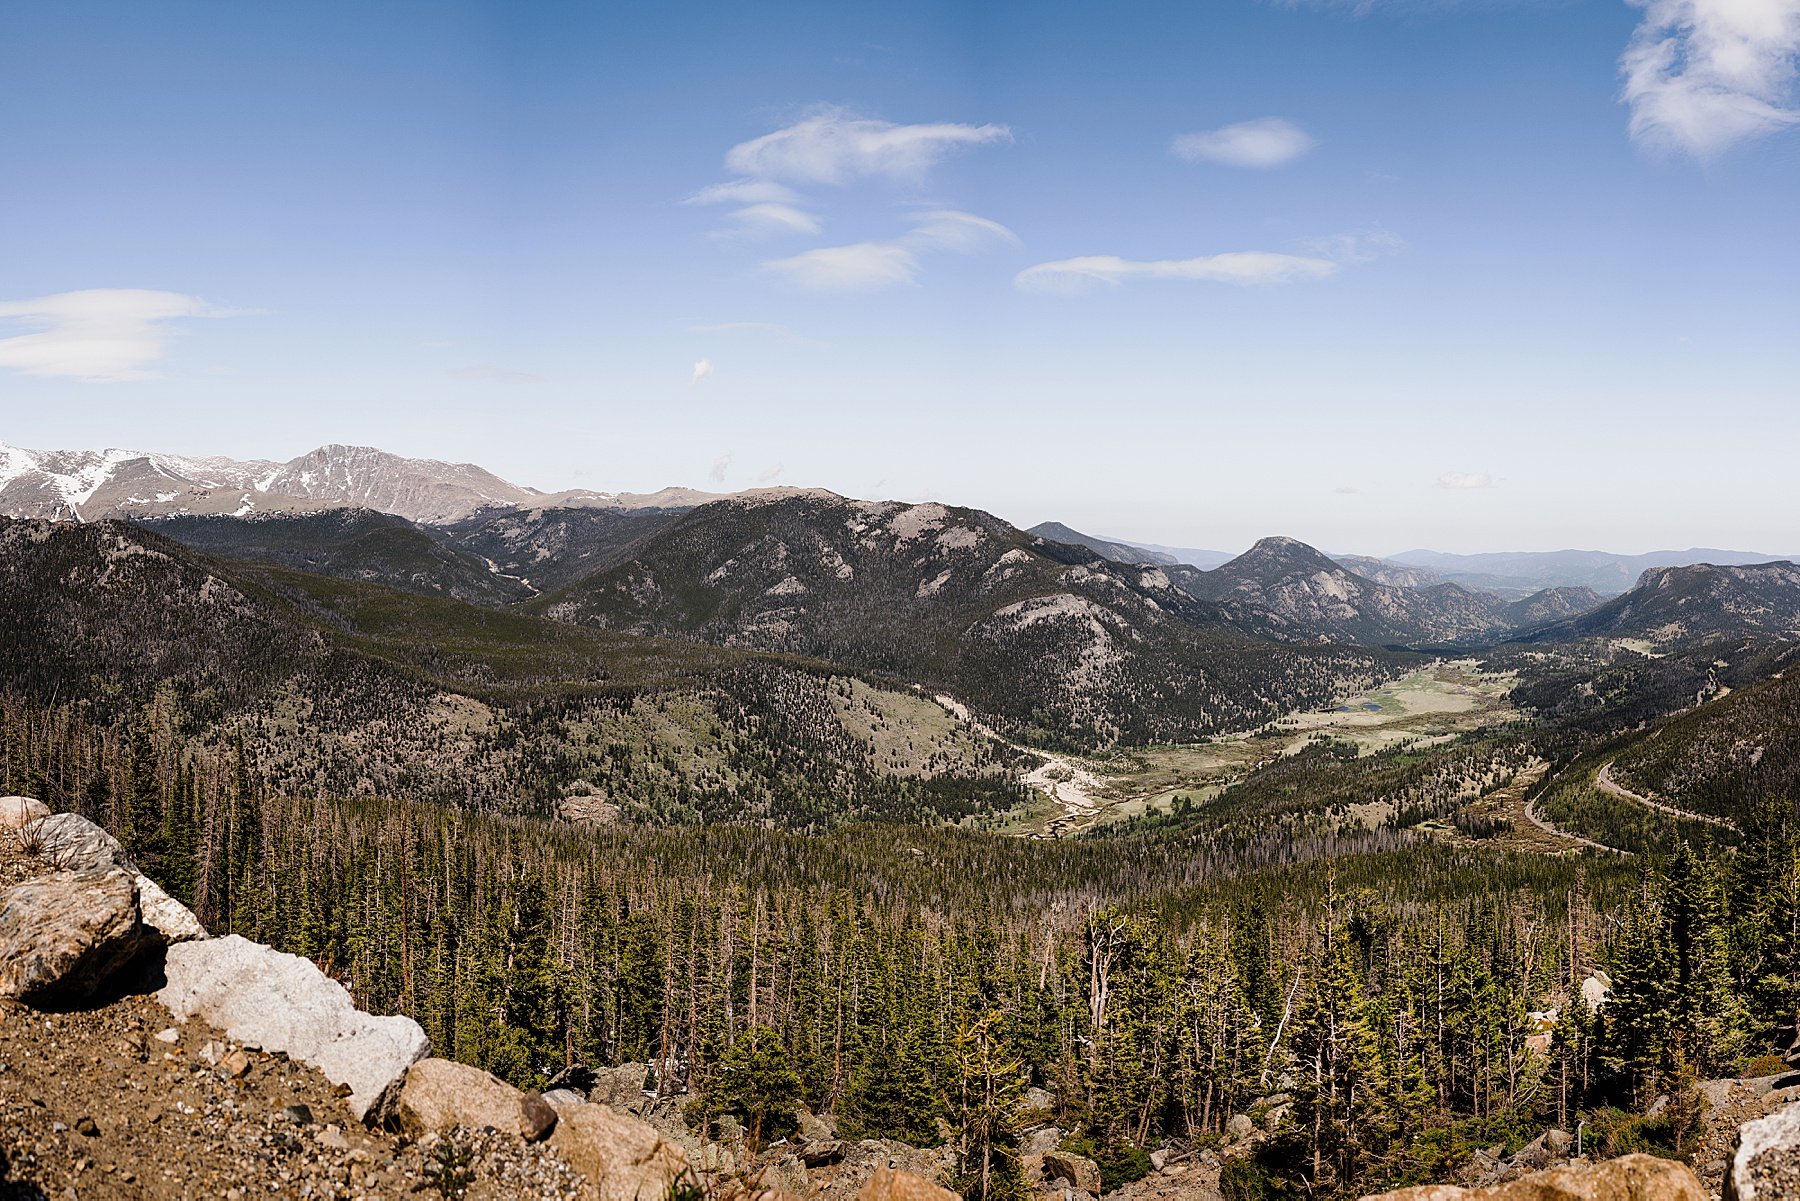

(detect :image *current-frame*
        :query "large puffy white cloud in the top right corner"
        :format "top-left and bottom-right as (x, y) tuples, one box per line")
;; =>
(1618, 0), (1800, 158)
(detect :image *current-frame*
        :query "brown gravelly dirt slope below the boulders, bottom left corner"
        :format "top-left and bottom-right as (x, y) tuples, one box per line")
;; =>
(0, 996), (581, 1201)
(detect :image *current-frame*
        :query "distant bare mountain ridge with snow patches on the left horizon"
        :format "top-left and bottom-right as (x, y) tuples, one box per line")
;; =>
(0, 443), (738, 524)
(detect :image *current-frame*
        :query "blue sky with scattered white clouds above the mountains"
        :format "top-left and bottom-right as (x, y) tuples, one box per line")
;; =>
(0, 0), (1800, 553)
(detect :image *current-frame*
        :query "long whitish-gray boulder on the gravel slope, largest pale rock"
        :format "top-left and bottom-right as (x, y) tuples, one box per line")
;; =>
(157, 935), (430, 1122)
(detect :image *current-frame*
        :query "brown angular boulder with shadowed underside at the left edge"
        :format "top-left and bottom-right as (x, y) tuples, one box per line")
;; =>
(0, 868), (155, 1005)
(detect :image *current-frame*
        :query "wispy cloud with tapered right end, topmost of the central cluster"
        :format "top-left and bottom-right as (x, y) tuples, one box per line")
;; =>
(725, 108), (1012, 184)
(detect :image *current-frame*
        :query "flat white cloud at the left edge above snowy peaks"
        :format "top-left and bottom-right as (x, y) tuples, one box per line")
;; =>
(0, 288), (236, 382)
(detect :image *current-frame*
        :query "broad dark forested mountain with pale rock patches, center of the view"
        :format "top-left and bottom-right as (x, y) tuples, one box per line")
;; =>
(533, 493), (1391, 747)
